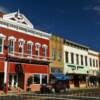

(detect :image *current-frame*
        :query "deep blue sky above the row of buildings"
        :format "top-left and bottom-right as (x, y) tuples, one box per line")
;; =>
(0, 0), (100, 51)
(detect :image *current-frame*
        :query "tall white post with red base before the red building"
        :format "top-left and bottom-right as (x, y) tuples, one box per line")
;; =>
(4, 46), (9, 95)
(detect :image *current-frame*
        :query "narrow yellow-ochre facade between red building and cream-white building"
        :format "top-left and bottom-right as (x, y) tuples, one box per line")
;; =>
(50, 35), (64, 74)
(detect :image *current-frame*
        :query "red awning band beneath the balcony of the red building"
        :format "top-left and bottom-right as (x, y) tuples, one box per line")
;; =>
(0, 61), (49, 74)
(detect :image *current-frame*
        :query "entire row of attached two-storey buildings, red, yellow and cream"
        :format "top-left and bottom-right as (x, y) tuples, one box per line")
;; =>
(0, 11), (100, 91)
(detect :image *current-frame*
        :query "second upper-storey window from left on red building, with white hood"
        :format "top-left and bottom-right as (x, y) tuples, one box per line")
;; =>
(8, 36), (16, 54)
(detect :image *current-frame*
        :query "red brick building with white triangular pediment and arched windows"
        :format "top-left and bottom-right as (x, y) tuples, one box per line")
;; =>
(0, 11), (51, 91)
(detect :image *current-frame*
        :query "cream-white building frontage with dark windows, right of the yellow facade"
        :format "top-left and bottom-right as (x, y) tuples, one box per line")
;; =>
(64, 40), (99, 88)
